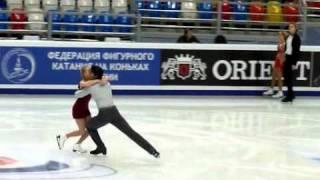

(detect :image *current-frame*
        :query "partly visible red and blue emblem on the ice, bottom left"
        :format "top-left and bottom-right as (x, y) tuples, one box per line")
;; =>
(0, 147), (117, 180)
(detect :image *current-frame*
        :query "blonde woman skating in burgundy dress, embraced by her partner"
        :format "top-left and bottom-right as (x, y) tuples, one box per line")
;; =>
(56, 65), (107, 153)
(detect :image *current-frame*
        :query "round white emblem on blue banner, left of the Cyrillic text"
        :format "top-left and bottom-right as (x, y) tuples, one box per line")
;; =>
(1, 48), (36, 84)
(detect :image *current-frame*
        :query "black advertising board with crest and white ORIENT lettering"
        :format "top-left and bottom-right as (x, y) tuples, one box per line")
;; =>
(161, 50), (311, 87)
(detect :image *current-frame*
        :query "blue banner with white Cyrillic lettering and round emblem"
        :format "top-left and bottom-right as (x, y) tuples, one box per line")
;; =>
(0, 47), (160, 85)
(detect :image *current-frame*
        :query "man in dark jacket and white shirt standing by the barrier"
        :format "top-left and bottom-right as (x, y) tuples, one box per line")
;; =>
(282, 23), (301, 102)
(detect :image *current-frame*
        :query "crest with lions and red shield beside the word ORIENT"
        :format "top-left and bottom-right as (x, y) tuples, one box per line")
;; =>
(161, 54), (207, 80)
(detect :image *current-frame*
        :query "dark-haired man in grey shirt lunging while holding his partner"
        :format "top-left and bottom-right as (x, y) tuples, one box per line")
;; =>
(75, 65), (160, 158)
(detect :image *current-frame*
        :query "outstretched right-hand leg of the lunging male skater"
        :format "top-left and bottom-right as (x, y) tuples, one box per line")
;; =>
(110, 108), (159, 157)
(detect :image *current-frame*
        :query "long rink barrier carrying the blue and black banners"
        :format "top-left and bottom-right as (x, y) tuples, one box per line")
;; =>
(0, 40), (320, 96)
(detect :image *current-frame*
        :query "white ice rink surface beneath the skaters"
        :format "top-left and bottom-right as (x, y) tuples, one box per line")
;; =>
(0, 95), (320, 180)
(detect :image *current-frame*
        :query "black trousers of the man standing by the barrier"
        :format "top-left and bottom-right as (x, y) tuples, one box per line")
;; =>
(283, 55), (295, 99)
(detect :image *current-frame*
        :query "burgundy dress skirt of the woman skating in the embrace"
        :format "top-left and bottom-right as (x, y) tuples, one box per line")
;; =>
(72, 95), (91, 119)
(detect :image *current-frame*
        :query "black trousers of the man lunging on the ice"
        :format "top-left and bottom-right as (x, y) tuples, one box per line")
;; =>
(87, 106), (156, 154)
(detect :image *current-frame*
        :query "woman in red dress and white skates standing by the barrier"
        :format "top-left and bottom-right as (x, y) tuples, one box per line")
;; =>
(263, 32), (286, 98)
